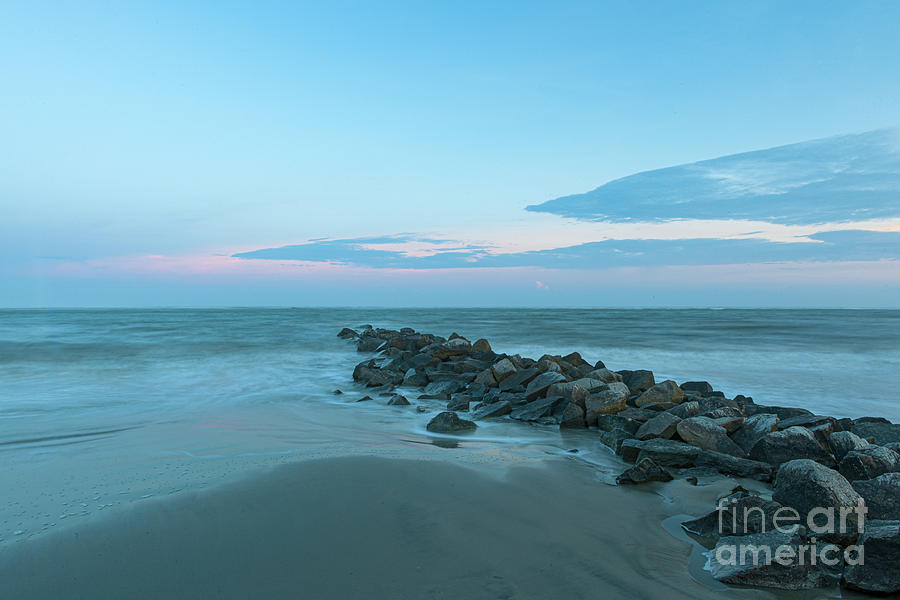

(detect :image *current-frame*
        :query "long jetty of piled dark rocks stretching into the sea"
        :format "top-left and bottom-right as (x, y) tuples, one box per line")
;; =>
(338, 325), (900, 595)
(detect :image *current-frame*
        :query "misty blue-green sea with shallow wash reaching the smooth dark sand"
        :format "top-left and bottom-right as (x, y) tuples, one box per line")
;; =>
(0, 308), (900, 544)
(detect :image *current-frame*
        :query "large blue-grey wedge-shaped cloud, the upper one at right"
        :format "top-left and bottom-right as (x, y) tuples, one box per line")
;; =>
(527, 129), (900, 224)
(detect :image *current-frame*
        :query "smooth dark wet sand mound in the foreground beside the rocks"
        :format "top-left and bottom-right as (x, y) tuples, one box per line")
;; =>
(0, 457), (788, 600)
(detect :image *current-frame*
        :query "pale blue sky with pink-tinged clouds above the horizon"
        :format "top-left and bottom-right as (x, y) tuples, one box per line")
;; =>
(0, 1), (900, 307)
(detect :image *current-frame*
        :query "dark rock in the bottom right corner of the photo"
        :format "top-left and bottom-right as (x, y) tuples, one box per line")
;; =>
(843, 521), (900, 594)
